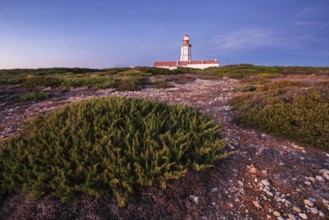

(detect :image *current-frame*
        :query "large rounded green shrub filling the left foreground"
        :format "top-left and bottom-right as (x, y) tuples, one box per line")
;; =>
(0, 98), (227, 206)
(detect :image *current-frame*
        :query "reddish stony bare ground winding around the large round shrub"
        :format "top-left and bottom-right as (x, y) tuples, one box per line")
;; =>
(0, 75), (329, 219)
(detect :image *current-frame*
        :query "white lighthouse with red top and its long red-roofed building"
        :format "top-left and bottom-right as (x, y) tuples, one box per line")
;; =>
(154, 34), (219, 69)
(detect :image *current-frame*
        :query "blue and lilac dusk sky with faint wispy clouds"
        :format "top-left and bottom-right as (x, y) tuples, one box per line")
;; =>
(0, 0), (329, 69)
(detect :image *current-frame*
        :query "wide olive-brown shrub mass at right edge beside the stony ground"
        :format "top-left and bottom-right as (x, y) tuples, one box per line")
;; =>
(231, 81), (329, 151)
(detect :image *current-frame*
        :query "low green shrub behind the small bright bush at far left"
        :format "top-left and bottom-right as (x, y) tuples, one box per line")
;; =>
(22, 76), (61, 88)
